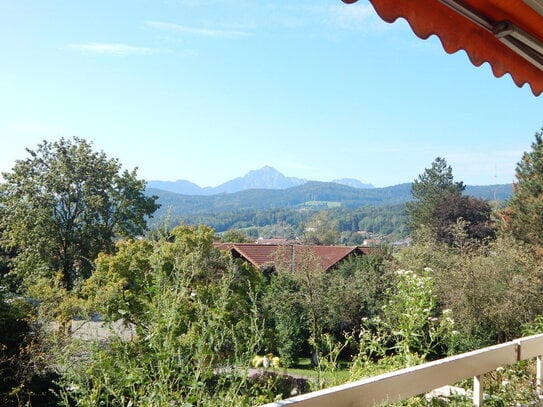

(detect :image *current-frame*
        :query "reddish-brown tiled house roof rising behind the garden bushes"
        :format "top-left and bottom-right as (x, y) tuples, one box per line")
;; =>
(217, 243), (374, 271)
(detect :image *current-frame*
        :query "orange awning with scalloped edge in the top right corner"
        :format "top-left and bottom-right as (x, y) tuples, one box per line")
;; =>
(343, 0), (543, 96)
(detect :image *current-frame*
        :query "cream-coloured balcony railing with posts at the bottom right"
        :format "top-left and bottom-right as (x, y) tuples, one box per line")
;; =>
(261, 334), (543, 407)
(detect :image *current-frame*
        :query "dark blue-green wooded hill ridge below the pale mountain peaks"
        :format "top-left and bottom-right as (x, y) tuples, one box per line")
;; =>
(147, 181), (511, 217)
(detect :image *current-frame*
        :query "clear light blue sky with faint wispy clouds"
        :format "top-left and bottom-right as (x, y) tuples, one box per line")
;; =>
(0, 0), (543, 187)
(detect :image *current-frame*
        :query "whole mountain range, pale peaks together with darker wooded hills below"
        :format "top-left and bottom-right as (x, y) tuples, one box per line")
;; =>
(146, 167), (512, 222)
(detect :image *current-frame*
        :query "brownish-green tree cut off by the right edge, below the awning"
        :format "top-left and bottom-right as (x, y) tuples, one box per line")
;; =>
(502, 129), (543, 248)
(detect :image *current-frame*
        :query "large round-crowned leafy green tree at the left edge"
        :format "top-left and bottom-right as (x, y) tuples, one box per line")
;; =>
(0, 137), (158, 290)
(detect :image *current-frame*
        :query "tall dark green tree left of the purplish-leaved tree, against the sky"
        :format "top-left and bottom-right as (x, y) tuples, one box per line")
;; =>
(407, 157), (465, 239)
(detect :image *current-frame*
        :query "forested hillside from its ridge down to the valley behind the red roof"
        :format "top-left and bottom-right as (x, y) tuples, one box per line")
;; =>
(147, 182), (512, 239)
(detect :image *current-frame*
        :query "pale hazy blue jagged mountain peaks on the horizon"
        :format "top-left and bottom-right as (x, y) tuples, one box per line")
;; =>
(147, 166), (373, 196)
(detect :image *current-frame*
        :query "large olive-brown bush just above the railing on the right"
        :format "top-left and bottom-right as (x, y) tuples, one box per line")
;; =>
(396, 234), (543, 352)
